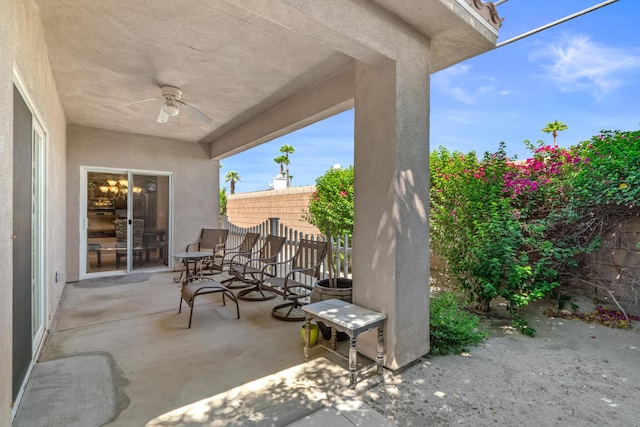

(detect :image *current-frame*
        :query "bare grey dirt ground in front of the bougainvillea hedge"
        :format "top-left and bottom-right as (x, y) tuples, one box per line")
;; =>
(362, 297), (640, 426)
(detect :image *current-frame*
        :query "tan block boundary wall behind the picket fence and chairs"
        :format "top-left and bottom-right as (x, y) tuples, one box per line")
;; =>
(227, 185), (321, 235)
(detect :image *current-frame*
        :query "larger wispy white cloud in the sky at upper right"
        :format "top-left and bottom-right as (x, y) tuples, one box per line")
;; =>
(529, 34), (640, 99)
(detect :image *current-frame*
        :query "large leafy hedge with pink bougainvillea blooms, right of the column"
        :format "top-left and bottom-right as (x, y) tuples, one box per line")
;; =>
(430, 131), (640, 335)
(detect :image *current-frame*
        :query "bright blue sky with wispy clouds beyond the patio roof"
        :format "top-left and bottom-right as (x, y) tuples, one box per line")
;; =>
(220, 0), (640, 193)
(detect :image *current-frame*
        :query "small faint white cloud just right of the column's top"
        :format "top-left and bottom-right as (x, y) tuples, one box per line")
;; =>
(431, 64), (496, 105)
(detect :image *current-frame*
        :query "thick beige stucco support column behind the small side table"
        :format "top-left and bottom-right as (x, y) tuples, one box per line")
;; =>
(353, 51), (429, 370)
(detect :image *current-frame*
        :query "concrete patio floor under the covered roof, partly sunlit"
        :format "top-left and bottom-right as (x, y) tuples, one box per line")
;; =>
(14, 272), (392, 427)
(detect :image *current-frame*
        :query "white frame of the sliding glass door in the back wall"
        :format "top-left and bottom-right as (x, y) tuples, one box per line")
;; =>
(78, 165), (173, 280)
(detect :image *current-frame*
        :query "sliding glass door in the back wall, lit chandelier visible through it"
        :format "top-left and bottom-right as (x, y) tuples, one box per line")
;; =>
(81, 169), (171, 276)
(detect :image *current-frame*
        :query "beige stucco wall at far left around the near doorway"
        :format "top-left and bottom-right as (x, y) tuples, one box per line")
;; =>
(0, 0), (66, 425)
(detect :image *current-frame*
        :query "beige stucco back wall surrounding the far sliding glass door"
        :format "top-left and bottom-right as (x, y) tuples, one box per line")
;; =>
(66, 125), (220, 281)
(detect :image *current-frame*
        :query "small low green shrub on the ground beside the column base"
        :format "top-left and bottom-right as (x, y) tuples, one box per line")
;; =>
(429, 292), (487, 355)
